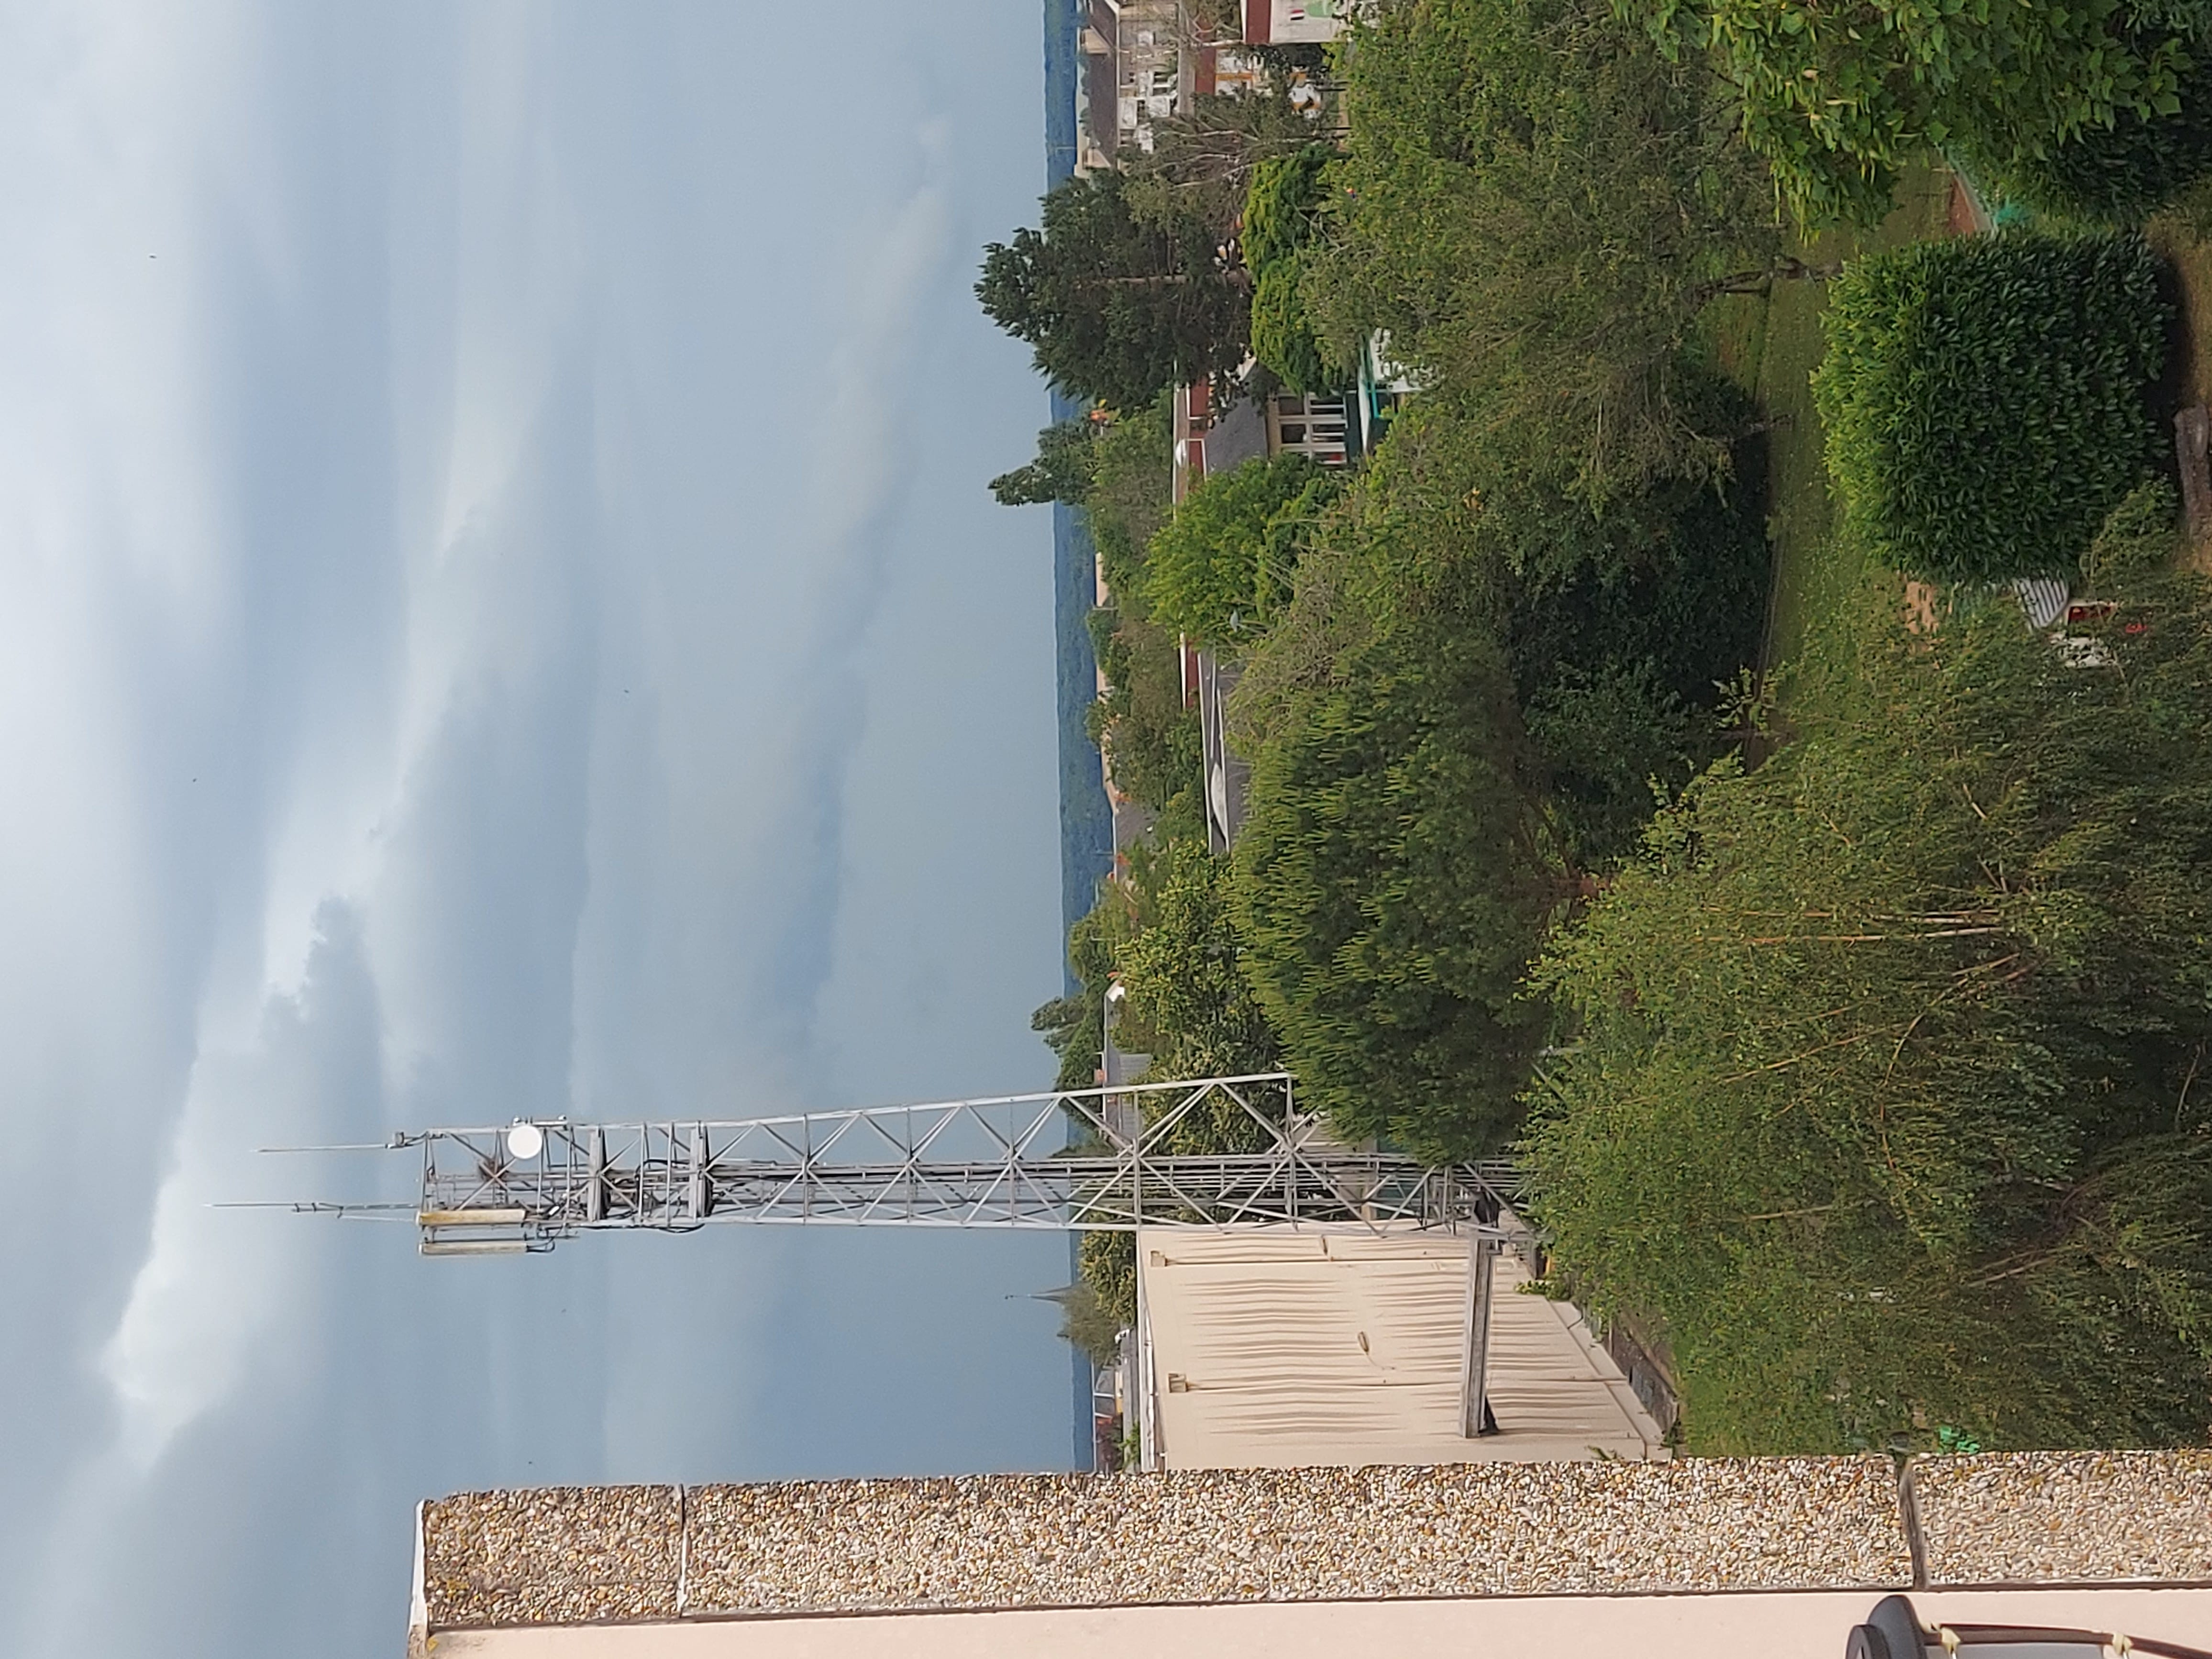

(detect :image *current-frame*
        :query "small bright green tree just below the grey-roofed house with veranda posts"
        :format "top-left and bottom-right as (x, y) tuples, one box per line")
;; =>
(1144, 453), (1340, 650)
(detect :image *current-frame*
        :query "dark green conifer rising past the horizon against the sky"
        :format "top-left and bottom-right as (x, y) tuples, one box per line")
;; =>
(975, 173), (1250, 409)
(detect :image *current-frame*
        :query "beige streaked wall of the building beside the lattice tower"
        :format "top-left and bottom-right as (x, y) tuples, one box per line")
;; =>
(1139, 1228), (1668, 1469)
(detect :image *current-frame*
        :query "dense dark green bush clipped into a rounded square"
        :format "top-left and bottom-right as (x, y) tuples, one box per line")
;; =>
(1814, 232), (2168, 582)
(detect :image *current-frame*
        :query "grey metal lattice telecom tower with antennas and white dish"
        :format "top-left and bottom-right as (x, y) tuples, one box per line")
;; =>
(394, 1073), (1513, 1254)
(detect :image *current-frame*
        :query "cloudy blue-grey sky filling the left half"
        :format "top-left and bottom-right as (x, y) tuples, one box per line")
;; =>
(0, 0), (1073, 1659)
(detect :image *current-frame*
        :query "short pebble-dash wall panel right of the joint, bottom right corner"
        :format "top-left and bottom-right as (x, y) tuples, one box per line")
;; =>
(1911, 1451), (2212, 1584)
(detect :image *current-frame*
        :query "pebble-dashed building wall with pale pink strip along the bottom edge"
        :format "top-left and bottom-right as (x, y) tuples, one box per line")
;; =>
(409, 1451), (2212, 1659)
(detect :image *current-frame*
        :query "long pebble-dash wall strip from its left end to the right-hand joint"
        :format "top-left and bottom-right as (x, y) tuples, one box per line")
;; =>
(422, 1458), (1911, 1628)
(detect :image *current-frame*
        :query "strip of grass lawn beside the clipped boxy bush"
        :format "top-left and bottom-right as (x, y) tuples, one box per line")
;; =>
(1703, 168), (1951, 703)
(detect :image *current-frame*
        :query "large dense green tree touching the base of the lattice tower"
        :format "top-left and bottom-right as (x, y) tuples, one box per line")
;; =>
(1232, 487), (1568, 1155)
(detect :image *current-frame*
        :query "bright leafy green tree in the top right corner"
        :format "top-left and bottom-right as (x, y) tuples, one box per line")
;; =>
(1621, 0), (2212, 223)
